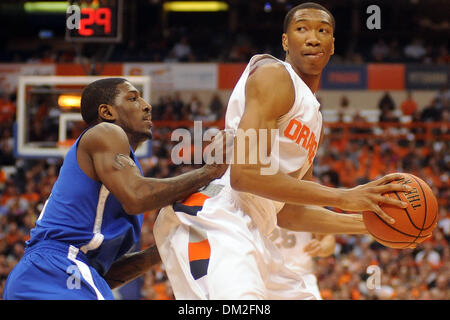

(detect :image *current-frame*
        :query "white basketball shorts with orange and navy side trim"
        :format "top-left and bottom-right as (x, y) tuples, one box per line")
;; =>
(154, 187), (315, 300)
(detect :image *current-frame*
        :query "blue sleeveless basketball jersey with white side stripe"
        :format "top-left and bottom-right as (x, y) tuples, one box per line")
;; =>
(27, 129), (144, 275)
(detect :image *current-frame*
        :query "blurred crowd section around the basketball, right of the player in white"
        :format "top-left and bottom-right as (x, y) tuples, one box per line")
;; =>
(315, 121), (450, 300)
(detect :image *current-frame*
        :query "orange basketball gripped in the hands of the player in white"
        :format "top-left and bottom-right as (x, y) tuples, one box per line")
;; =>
(363, 173), (438, 249)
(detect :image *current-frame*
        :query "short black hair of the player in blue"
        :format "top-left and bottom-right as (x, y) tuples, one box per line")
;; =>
(81, 78), (127, 126)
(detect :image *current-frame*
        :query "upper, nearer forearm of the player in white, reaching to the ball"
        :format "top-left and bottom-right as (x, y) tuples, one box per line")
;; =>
(231, 165), (345, 208)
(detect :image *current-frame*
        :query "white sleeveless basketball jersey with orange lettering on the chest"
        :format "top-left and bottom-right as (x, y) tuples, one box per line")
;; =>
(216, 54), (322, 235)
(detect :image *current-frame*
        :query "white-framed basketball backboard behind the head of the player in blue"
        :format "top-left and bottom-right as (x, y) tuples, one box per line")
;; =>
(14, 76), (151, 158)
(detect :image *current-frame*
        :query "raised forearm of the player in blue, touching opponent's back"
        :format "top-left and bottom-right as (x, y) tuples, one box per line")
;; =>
(125, 167), (217, 214)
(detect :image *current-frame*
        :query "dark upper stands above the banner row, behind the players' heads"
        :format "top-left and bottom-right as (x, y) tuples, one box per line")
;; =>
(0, 0), (450, 64)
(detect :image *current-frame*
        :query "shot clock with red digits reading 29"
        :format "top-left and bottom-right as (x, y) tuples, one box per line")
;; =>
(66, 0), (123, 42)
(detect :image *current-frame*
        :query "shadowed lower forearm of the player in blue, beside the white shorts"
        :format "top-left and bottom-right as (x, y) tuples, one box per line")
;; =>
(104, 246), (161, 289)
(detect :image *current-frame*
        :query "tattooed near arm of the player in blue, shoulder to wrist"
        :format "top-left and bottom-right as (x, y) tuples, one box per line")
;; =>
(79, 123), (227, 214)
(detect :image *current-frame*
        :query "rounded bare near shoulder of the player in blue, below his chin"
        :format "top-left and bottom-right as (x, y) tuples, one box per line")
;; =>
(81, 122), (129, 150)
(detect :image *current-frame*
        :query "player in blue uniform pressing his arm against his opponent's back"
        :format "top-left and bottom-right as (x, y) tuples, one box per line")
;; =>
(4, 78), (232, 299)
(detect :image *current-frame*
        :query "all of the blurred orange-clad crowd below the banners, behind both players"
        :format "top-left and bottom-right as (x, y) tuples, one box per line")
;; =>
(0, 86), (450, 299)
